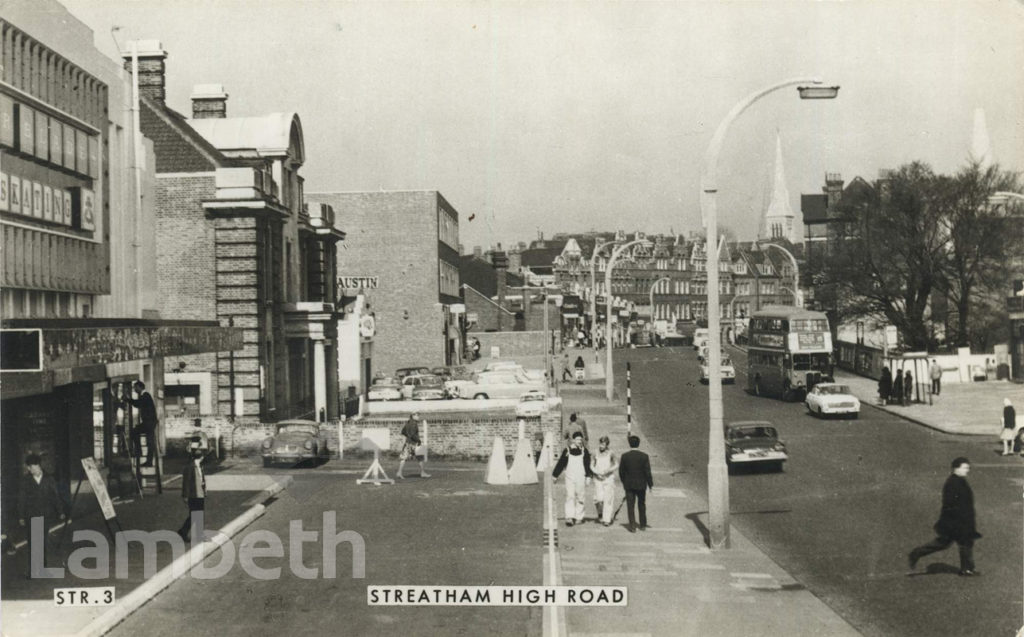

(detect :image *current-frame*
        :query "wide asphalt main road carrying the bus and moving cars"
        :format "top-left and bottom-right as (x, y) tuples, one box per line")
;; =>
(615, 348), (1024, 637)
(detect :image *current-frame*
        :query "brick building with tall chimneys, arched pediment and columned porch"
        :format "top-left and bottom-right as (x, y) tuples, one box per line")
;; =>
(125, 40), (343, 421)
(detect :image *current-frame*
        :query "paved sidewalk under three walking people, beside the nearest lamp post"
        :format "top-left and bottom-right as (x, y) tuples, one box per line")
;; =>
(554, 386), (858, 637)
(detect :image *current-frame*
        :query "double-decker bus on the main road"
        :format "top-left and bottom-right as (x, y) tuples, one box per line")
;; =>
(746, 305), (835, 400)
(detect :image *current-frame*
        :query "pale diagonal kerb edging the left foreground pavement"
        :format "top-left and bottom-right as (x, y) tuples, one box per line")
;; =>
(76, 480), (289, 637)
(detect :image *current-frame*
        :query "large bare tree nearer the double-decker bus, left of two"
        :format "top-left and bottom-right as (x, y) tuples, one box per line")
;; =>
(823, 162), (946, 349)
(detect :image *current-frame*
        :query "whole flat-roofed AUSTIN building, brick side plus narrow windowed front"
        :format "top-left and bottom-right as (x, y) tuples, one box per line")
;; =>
(306, 190), (464, 381)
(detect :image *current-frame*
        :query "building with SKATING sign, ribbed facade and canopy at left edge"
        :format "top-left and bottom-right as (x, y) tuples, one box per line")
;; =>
(0, 0), (241, 516)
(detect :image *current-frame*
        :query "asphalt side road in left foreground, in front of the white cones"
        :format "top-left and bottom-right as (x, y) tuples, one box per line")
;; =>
(111, 460), (543, 637)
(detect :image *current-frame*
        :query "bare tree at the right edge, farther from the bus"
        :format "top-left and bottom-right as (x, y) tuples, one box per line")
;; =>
(933, 163), (1024, 349)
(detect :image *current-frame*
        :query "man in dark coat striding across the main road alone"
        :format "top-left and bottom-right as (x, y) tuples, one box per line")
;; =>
(908, 457), (981, 577)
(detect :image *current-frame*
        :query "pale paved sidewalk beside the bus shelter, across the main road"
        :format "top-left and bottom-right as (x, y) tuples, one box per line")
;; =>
(836, 369), (1024, 439)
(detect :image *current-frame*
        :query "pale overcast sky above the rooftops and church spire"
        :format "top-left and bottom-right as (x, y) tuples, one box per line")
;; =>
(65, 0), (1024, 249)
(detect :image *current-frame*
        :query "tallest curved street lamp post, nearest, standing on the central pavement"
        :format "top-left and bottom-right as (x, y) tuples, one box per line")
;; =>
(700, 78), (839, 549)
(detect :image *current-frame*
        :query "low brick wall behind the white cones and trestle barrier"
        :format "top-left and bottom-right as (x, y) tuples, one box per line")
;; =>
(164, 408), (562, 458)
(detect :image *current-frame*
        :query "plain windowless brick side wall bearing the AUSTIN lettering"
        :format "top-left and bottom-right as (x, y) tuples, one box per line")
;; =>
(306, 192), (459, 373)
